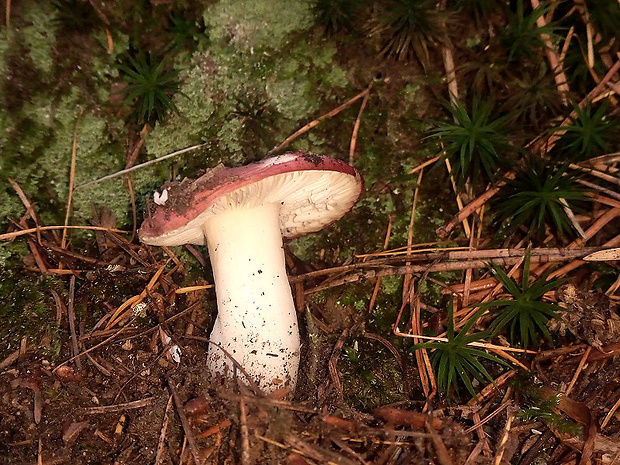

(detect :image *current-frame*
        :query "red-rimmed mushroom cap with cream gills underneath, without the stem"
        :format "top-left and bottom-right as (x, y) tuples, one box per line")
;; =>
(138, 152), (363, 246)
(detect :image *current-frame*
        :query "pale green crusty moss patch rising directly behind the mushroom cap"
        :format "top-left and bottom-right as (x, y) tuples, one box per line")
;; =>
(147, 0), (347, 167)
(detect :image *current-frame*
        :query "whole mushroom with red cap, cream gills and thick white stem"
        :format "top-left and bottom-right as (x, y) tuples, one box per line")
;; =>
(139, 152), (363, 392)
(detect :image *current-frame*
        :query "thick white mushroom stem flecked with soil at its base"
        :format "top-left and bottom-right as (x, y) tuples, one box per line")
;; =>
(203, 203), (299, 392)
